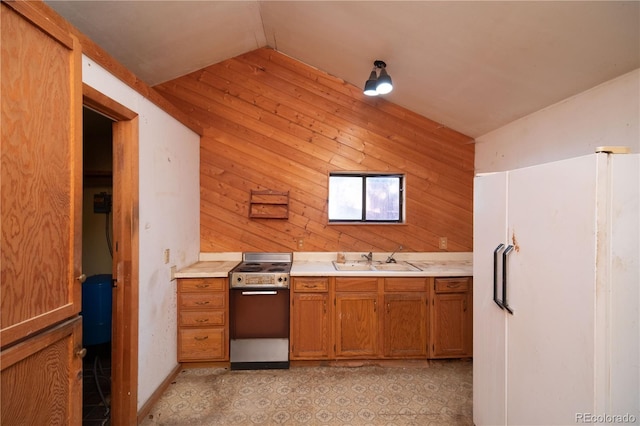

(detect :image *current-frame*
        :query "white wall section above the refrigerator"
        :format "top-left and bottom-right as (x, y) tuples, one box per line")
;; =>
(475, 69), (640, 173)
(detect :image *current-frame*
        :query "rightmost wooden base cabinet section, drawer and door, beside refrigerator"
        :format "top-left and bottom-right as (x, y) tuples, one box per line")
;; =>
(430, 277), (473, 358)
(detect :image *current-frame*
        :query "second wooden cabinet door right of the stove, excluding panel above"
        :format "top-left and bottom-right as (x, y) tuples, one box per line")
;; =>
(336, 293), (379, 358)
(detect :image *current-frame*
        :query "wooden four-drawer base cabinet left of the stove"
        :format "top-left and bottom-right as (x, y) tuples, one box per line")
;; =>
(178, 278), (229, 362)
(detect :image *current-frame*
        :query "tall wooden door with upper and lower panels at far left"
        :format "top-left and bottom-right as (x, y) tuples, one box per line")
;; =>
(0, 1), (83, 425)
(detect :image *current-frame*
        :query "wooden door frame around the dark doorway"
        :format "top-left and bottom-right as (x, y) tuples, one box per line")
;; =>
(82, 83), (139, 425)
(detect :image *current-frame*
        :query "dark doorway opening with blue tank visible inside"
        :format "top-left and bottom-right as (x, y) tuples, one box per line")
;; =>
(81, 107), (114, 425)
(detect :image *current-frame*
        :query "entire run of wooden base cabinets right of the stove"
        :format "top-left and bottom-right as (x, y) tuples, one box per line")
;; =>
(290, 277), (473, 360)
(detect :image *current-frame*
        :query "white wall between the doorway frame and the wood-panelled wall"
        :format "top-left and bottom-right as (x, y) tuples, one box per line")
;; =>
(82, 55), (200, 410)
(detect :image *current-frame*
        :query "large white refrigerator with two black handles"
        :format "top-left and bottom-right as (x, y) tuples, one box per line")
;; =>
(473, 153), (640, 426)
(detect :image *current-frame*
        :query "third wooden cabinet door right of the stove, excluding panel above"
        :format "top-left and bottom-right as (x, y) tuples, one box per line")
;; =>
(384, 293), (427, 358)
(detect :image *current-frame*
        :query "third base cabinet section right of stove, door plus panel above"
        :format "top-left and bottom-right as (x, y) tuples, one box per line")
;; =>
(383, 278), (429, 358)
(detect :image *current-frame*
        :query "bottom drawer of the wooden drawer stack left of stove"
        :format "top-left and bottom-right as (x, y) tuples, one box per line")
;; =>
(178, 327), (225, 361)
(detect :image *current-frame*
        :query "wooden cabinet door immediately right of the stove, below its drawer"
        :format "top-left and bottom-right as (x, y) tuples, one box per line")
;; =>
(291, 293), (331, 359)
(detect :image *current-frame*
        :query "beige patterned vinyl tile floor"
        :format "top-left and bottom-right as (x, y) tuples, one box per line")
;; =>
(141, 360), (473, 426)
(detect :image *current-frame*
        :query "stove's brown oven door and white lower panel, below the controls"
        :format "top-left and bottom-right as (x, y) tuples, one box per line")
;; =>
(229, 288), (289, 370)
